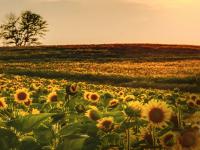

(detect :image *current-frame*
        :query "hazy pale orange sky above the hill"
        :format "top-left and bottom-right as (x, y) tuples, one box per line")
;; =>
(0, 0), (200, 45)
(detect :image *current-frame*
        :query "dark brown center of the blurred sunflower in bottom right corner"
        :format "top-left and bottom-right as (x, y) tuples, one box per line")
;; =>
(180, 132), (196, 148)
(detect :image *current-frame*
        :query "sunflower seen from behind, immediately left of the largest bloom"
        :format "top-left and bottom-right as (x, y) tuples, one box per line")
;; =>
(125, 101), (143, 117)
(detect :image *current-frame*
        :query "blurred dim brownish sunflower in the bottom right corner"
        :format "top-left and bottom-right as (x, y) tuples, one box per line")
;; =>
(177, 129), (200, 150)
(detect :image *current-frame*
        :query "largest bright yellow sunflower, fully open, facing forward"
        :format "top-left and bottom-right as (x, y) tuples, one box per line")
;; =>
(143, 100), (172, 127)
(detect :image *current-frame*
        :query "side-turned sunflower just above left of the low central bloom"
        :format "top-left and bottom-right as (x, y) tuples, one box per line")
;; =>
(85, 106), (100, 121)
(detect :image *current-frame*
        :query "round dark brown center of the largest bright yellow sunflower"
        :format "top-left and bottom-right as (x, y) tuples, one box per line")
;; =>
(149, 108), (164, 123)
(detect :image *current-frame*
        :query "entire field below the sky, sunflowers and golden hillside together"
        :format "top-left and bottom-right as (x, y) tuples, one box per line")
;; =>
(0, 44), (200, 150)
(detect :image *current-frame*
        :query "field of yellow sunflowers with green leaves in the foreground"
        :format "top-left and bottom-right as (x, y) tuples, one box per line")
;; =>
(0, 74), (200, 150)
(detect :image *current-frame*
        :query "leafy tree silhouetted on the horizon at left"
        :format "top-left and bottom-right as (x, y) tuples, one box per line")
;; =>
(0, 11), (48, 46)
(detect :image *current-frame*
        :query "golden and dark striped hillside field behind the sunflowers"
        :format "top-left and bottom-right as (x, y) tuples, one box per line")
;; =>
(0, 44), (200, 92)
